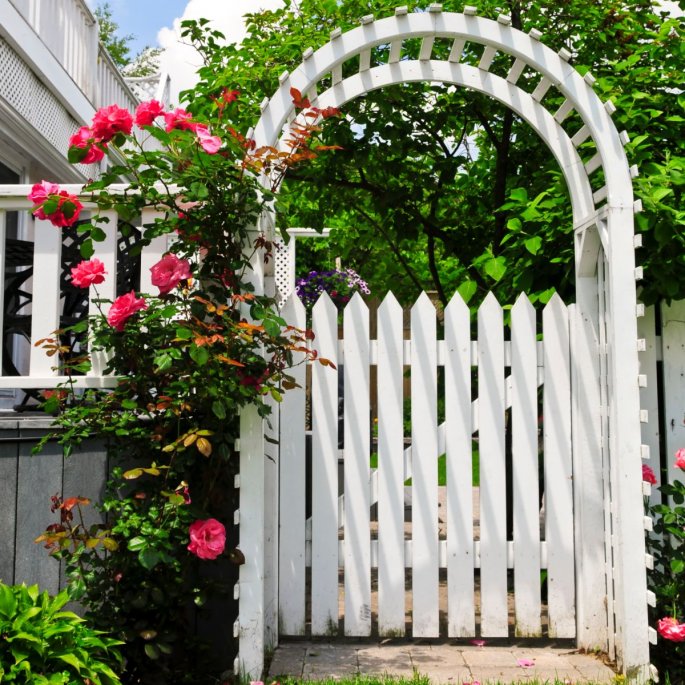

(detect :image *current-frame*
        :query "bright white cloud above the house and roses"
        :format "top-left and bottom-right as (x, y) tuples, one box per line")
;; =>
(157, 0), (283, 103)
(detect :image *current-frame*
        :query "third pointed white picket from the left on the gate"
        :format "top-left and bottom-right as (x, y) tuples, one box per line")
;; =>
(343, 293), (371, 636)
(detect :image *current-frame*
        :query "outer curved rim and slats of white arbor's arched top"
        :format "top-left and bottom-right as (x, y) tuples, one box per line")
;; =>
(253, 5), (633, 216)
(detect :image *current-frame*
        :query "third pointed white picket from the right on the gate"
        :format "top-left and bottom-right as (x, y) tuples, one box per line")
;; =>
(478, 293), (509, 637)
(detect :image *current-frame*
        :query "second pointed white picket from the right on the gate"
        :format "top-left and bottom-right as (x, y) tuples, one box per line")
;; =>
(511, 294), (542, 637)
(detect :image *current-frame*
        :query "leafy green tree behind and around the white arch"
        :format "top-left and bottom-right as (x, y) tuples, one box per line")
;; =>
(180, 0), (685, 303)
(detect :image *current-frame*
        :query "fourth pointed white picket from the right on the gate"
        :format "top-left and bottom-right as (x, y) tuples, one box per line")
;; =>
(445, 294), (476, 637)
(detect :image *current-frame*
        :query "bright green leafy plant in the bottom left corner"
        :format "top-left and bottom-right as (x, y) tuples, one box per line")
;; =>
(0, 583), (121, 685)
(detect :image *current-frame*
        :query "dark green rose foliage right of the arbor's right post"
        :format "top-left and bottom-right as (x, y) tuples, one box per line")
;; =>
(648, 470), (685, 683)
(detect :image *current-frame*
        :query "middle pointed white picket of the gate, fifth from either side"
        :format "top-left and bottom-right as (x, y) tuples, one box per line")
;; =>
(411, 293), (439, 638)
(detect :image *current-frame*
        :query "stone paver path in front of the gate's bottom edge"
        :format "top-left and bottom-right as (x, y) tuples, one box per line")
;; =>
(267, 641), (616, 685)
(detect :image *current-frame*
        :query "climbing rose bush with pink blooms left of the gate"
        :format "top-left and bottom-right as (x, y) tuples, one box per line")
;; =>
(34, 38), (336, 685)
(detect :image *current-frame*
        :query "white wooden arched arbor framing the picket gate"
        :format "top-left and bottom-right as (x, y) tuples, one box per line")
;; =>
(239, 5), (649, 681)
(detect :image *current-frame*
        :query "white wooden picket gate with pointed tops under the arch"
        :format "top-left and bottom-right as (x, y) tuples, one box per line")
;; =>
(279, 294), (575, 638)
